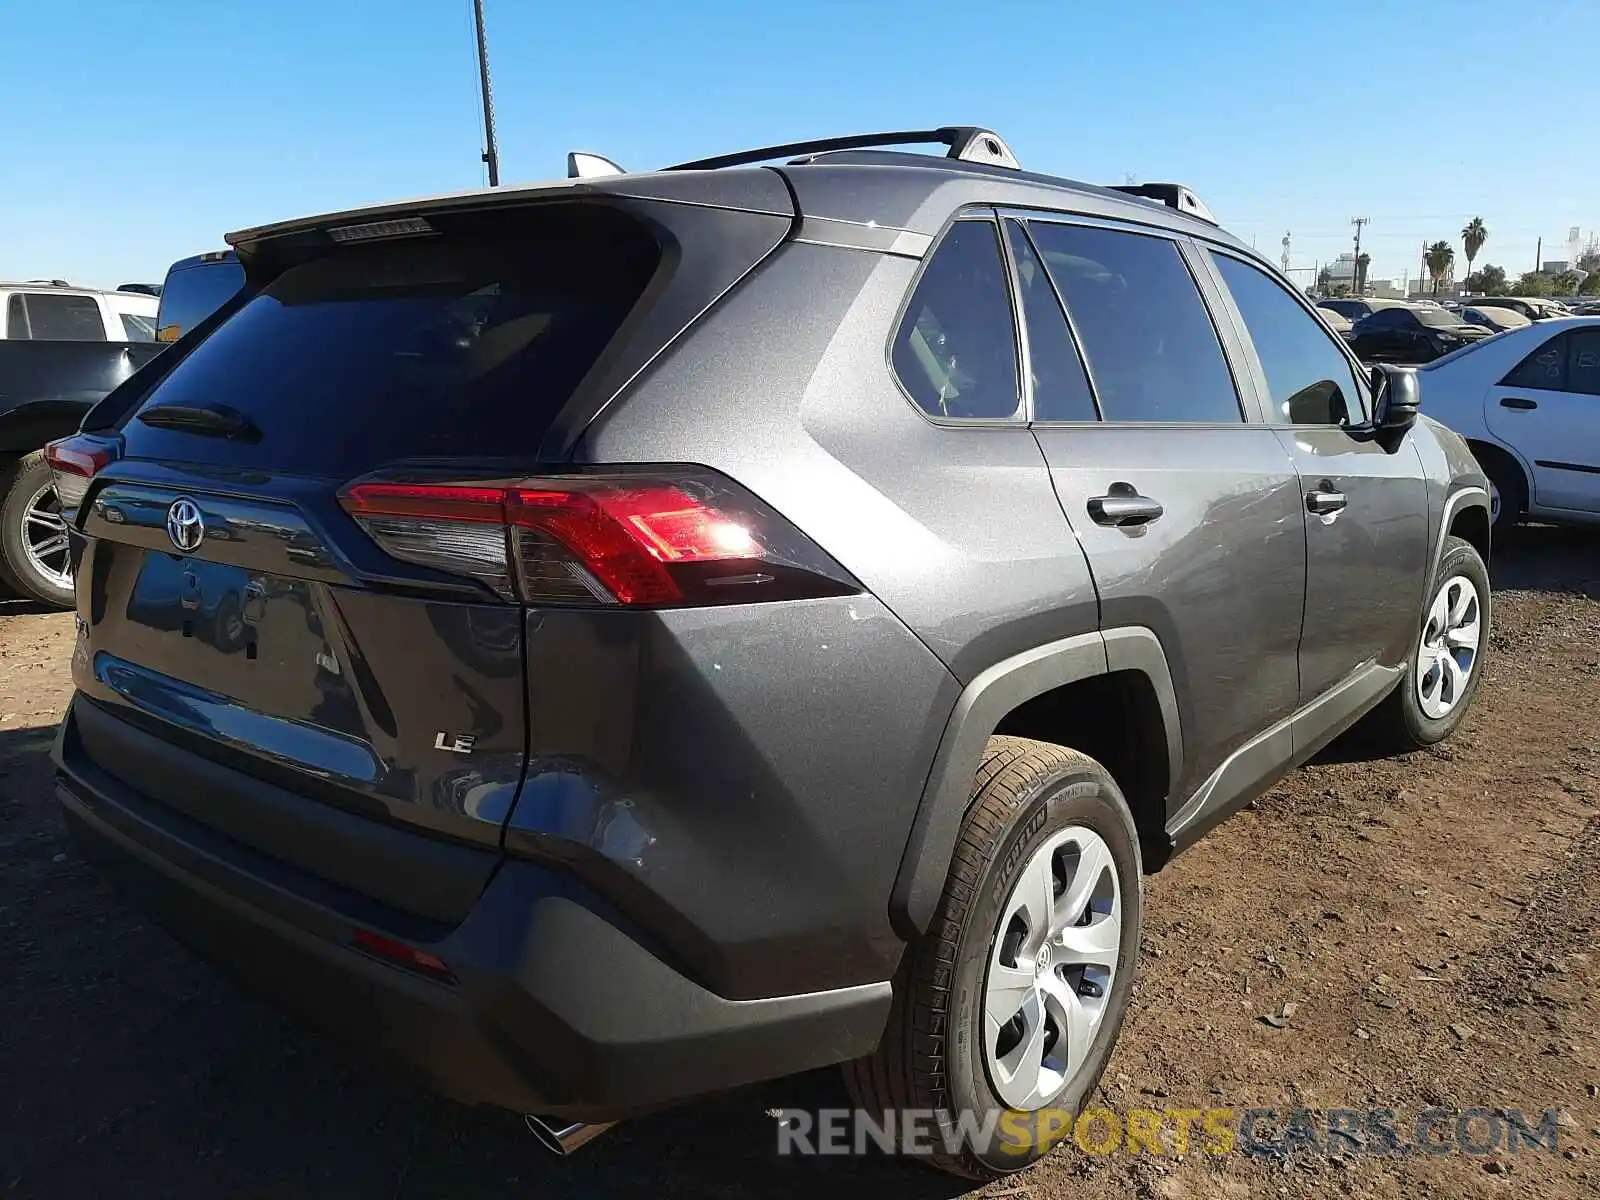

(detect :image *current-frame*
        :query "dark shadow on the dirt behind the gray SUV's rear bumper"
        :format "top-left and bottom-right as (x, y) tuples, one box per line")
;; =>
(0, 728), (963, 1200)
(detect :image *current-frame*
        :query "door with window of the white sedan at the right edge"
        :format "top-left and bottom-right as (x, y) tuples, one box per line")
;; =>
(1483, 325), (1600, 512)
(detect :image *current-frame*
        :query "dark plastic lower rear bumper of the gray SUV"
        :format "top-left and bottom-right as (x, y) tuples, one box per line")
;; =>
(56, 701), (891, 1120)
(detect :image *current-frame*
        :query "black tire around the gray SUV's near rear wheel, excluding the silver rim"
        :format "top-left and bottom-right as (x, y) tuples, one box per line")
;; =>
(845, 738), (1144, 1179)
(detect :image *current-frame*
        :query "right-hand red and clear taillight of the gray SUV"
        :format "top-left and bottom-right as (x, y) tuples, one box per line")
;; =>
(341, 472), (856, 606)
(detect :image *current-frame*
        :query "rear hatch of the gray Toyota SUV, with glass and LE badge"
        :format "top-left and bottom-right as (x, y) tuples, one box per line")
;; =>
(64, 185), (790, 920)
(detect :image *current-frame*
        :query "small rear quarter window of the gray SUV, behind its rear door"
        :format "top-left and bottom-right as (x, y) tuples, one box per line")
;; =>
(893, 221), (1019, 418)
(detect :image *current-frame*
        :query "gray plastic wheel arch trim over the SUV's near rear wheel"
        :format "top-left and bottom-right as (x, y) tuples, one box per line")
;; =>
(890, 626), (1184, 941)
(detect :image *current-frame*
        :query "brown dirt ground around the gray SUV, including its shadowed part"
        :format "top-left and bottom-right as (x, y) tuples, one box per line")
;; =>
(0, 528), (1600, 1200)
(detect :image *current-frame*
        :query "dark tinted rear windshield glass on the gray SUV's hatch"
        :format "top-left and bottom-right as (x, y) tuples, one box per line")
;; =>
(123, 206), (659, 477)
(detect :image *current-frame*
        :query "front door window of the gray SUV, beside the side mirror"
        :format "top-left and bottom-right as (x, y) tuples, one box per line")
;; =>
(1211, 254), (1362, 426)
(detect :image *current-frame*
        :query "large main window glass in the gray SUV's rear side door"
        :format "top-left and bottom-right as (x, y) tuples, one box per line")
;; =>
(1029, 221), (1243, 422)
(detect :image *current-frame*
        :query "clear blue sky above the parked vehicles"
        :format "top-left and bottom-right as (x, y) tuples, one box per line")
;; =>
(0, 0), (1600, 285)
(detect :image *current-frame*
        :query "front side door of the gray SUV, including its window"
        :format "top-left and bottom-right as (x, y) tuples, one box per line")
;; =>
(1210, 248), (1430, 704)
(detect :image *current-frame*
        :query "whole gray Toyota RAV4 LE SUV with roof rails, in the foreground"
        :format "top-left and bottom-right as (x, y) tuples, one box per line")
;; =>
(50, 126), (1490, 1178)
